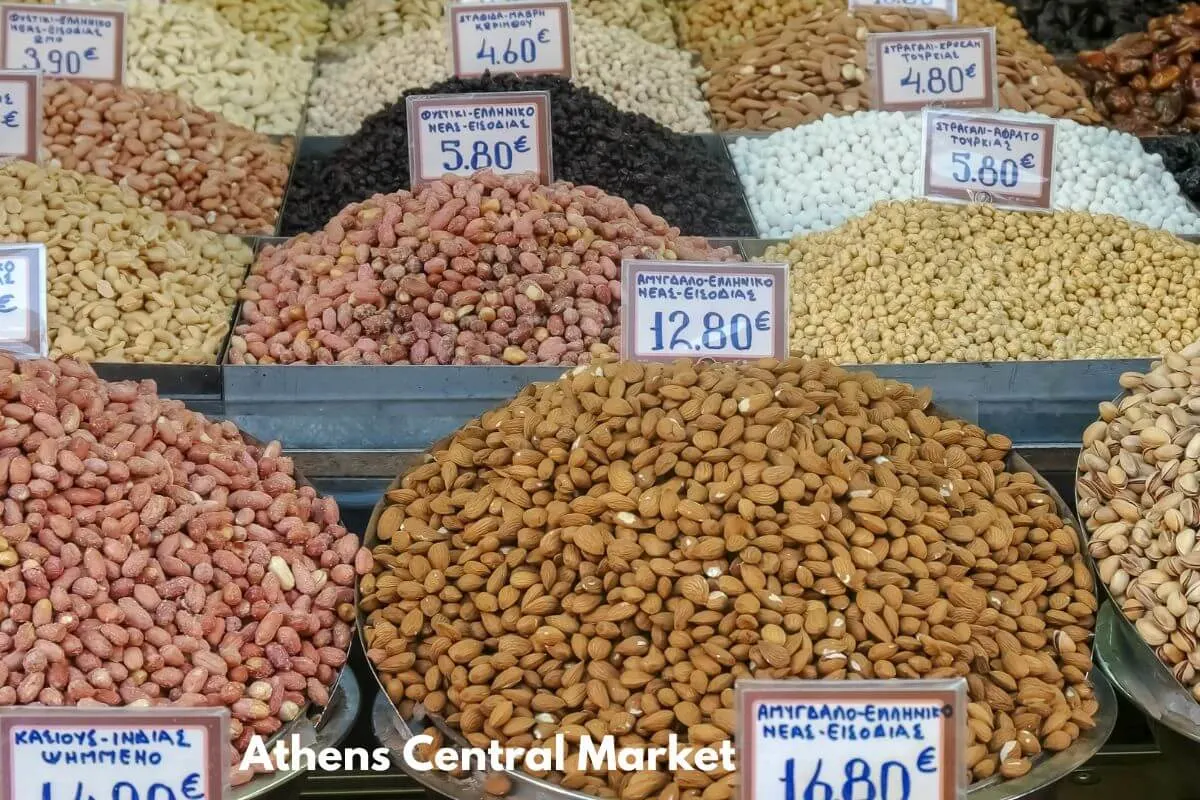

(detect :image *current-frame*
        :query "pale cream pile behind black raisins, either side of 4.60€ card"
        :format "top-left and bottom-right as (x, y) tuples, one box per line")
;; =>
(307, 17), (712, 136)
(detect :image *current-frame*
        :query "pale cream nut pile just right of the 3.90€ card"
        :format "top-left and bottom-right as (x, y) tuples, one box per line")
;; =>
(125, 0), (312, 134)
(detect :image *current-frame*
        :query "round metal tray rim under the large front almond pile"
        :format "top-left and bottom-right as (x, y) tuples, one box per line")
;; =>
(358, 386), (1117, 800)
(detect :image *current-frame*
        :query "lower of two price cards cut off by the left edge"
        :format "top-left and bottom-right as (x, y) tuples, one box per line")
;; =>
(0, 243), (49, 357)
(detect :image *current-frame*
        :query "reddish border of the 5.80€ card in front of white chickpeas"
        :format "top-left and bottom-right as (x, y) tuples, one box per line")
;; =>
(919, 108), (1057, 211)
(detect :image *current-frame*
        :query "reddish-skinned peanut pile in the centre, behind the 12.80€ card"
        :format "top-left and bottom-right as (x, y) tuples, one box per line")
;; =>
(229, 172), (733, 365)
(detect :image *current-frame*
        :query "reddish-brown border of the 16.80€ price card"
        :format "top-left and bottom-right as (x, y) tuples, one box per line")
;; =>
(734, 678), (967, 800)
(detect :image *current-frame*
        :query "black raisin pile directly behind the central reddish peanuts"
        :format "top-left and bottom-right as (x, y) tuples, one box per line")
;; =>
(282, 74), (755, 236)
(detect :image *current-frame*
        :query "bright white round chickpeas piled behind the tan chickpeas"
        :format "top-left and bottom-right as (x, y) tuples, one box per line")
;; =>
(730, 112), (1200, 236)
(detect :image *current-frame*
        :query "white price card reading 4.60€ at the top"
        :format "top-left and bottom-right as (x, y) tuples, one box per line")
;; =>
(446, 0), (571, 78)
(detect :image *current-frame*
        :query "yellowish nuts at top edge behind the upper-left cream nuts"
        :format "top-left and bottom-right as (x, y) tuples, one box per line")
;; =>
(180, 0), (329, 60)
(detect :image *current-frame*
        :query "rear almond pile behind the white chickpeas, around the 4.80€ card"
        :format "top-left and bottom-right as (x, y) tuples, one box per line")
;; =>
(704, 10), (1100, 130)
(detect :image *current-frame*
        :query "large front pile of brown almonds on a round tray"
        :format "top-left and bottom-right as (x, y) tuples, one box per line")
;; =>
(360, 359), (1097, 800)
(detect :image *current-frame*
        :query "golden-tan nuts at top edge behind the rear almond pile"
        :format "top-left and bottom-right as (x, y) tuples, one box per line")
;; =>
(677, 0), (1054, 65)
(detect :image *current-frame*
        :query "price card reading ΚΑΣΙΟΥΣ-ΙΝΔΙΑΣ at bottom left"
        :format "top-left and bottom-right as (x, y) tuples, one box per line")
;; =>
(0, 706), (229, 800)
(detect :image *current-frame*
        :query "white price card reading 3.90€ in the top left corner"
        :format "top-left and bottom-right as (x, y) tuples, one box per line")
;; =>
(0, 5), (125, 83)
